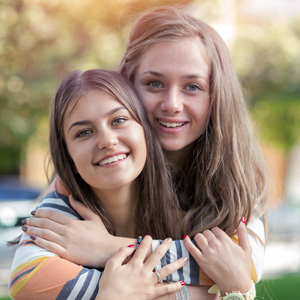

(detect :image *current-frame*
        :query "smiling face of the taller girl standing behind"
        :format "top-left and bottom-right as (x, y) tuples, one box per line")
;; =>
(135, 37), (210, 159)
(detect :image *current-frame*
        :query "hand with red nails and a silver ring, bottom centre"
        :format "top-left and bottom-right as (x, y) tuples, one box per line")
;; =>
(96, 236), (187, 300)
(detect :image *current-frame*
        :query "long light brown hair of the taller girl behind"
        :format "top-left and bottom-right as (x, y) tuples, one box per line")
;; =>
(119, 7), (268, 235)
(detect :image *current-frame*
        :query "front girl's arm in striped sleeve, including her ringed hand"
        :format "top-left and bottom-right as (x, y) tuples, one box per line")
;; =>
(9, 192), (186, 300)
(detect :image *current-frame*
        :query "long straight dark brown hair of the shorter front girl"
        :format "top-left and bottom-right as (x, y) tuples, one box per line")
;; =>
(49, 70), (180, 238)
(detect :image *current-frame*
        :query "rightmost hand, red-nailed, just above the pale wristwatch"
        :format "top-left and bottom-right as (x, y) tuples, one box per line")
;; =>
(184, 222), (251, 293)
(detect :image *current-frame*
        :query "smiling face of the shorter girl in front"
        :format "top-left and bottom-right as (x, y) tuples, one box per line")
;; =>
(64, 90), (146, 193)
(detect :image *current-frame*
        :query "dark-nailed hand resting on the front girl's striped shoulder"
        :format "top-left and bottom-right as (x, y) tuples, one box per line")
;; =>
(25, 196), (131, 268)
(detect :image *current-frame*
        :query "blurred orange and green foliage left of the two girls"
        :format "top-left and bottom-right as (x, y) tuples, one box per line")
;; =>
(0, 0), (190, 175)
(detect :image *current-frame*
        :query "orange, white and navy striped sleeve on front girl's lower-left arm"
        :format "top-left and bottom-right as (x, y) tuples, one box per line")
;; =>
(9, 234), (101, 300)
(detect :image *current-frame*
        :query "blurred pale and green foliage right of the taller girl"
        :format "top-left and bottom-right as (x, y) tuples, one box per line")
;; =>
(232, 18), (300, 151)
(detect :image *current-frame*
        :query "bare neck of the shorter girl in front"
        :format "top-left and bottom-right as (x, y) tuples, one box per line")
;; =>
(95, 180), (138, 237)
